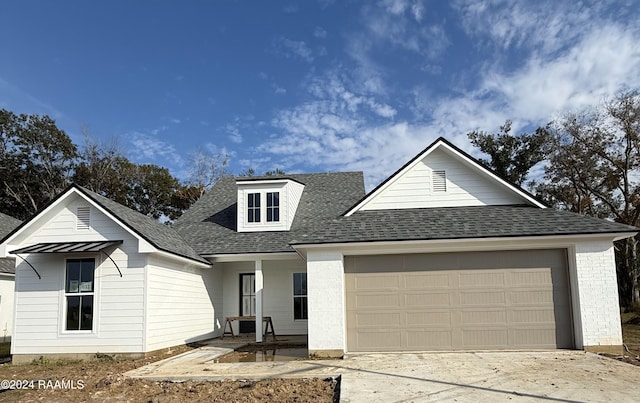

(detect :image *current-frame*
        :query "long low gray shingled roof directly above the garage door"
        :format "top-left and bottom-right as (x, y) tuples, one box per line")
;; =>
(291, 205), (638, 245)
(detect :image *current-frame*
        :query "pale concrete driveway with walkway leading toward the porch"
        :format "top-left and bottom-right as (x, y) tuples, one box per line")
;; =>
(127, 347), (640, 403)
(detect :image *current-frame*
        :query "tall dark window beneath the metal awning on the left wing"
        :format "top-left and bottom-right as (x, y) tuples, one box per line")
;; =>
(65, 259), (96, 330)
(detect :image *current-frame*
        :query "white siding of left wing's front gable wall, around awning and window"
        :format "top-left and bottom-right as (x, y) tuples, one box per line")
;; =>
(11, 195), (146, 354)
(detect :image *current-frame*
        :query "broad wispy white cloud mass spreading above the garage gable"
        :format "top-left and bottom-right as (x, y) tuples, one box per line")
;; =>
(252, 1), (640, 188)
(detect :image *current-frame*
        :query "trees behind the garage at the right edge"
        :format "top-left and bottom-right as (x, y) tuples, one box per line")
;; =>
(467, 90), (640, 308)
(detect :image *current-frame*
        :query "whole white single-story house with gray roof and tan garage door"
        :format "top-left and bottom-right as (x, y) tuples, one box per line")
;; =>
(0, 139), (637, 361)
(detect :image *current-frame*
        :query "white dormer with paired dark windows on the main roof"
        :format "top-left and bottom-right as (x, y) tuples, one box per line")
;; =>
(236, 178), (304, 232)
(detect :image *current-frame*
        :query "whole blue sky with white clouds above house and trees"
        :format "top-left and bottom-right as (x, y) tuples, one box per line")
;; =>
(0, 0), (640, 188)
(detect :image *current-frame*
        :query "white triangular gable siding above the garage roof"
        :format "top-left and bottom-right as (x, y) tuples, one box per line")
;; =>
(361, 149), (527, 210)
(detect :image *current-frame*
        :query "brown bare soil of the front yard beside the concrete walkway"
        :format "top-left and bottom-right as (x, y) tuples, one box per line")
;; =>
(0, 346), (338, 403)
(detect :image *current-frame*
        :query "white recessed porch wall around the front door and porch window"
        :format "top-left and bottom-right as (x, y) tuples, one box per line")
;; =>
(217, 260), (307, 335)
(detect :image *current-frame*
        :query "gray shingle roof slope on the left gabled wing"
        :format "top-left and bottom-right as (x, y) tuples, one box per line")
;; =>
(74, 185), (209, 263)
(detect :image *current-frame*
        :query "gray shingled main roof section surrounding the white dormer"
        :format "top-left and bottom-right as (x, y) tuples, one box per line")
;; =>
(173, 172), (365, 255)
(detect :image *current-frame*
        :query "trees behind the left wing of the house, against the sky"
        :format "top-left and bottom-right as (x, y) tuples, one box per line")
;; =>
(0, 109), (230, 220)
